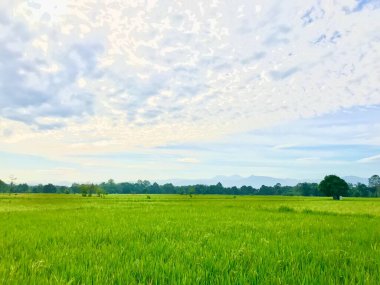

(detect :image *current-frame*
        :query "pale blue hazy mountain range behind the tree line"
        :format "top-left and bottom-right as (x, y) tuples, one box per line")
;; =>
(157, 175), (368, 188)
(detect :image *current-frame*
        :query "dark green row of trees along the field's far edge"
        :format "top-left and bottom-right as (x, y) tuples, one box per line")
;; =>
(0, 175), (380, 198)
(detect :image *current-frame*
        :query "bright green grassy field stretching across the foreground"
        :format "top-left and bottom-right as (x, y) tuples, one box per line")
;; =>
(0, 194), (380, 284)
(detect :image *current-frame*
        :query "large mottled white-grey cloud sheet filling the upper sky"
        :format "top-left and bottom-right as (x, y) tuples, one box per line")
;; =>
(0, 0), (380, 160)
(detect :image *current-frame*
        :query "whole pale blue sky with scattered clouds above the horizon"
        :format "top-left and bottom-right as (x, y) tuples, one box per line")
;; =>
(0, 0), (380, 183)
